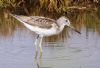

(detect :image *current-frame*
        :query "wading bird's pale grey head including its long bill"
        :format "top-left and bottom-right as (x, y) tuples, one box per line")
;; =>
(58, 16), (81, 34)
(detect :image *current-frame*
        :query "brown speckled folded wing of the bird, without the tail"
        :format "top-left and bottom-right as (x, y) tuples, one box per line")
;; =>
(25, 16), (56, 28)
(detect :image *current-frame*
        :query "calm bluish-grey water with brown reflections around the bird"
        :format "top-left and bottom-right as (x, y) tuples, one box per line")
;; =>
(0, 10), (100, 68)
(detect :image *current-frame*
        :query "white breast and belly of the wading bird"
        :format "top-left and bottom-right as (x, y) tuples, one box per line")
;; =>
(24, 23), (58, 36)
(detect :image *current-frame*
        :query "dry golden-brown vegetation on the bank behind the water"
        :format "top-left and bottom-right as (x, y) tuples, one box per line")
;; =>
(0, 0), (100, 14)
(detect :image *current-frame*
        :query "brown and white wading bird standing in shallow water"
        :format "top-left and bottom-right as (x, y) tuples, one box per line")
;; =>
(10, 14), (80, 53)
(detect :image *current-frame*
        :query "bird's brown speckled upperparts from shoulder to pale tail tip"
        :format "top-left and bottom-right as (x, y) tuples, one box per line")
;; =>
(10, 14), (57, 28)
